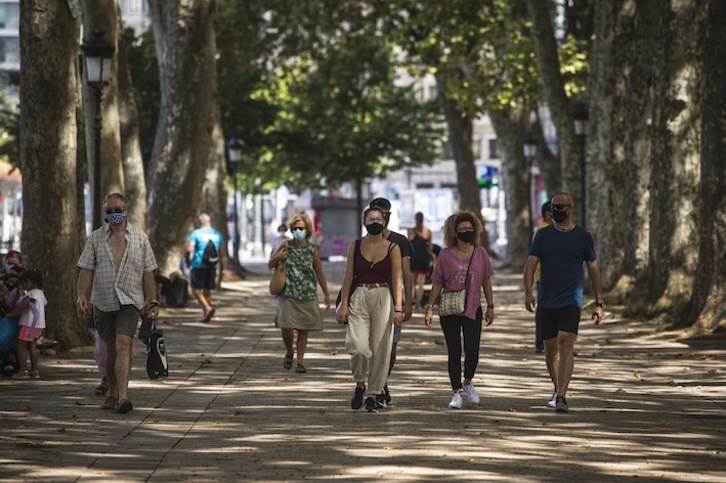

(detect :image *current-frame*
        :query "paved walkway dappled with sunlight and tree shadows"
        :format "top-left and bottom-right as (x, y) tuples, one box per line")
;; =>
(0, 263), (726, 482)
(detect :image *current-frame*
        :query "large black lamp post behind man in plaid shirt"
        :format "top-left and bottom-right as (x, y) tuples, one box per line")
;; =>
(81, 30), (115, 228)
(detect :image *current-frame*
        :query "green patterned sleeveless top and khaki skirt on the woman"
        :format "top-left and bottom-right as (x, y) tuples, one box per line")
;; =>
(276, 242), (323, 330)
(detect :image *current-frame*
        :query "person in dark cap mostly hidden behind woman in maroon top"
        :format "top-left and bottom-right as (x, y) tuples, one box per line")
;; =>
(369, 198), (413, 404)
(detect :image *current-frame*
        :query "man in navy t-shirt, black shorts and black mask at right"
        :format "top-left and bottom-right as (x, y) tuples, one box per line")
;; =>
(524, 193), (603, 412)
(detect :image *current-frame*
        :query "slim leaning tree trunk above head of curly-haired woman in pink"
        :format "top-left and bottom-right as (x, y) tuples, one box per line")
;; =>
(436, 73), (490, 250)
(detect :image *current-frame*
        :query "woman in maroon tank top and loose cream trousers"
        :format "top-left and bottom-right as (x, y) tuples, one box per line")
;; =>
(337, 208), (403, 412)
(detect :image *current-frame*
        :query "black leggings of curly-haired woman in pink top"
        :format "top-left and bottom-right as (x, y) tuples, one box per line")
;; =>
(440, 307), (482, 391)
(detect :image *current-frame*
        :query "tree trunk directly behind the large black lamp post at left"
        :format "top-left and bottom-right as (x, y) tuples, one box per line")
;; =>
(82, 0), (124, 228)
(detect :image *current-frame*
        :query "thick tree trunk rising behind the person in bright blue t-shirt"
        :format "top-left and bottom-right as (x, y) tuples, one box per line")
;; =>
(149, 0), (219, 273)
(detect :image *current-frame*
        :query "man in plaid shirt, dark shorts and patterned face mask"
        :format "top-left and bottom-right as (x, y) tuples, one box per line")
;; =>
(76, 193), (159, 413)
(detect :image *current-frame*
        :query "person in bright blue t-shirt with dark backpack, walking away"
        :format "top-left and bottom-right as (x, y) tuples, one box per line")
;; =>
(186, 213), (224, 324)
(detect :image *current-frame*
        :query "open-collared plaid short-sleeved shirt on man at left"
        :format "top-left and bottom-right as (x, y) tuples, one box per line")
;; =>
(78, 222), (157, 312)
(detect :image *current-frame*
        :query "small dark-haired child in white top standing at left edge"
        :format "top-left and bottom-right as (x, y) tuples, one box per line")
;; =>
(7, 270), (48, 379)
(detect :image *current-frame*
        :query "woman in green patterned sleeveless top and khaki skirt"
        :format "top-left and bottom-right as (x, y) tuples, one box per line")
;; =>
(267, 215), (330, 373)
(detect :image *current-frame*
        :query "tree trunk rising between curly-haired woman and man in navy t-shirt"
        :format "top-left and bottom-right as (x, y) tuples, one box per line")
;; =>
(489, 107), (535, 267)
